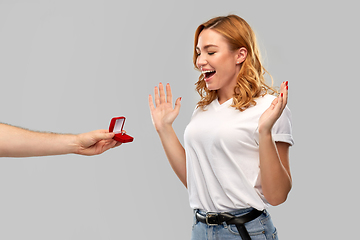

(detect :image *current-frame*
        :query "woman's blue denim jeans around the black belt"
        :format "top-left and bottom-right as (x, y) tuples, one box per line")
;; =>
(191, 208), (278, 240)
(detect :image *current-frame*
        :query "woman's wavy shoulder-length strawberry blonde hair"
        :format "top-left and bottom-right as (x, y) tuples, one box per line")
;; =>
(193, 15), (278, 111)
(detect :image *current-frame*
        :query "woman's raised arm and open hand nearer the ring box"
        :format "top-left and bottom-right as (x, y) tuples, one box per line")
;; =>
(149, 83), (187, 187)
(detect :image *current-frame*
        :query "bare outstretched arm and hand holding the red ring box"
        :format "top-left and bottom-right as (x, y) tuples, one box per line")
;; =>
(0, 124), (120, 157)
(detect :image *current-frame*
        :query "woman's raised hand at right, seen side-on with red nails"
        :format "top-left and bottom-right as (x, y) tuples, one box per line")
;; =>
(259, 81), (288, 133)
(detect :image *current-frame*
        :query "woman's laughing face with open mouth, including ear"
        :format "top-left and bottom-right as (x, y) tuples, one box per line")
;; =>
(196, 29), (244, 97)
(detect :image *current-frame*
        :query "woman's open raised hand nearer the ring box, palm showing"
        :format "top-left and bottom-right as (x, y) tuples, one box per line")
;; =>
(149, 83), (181, 132)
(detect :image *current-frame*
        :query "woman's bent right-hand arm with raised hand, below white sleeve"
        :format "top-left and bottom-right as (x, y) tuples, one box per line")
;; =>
(259, 82), (292, 206)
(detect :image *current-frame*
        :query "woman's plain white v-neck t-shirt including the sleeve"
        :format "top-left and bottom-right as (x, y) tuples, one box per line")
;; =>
(184, 95), (294, 212)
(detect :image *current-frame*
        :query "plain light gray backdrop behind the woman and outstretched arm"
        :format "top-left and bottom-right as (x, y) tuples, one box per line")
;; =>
(0, 0), (360, 240)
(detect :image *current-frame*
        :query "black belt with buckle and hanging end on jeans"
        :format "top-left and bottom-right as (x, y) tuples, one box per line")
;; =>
(196, 209), (263, 240)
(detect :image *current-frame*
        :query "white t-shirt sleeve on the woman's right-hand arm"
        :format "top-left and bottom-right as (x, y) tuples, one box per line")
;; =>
(272, 106), (294, 146)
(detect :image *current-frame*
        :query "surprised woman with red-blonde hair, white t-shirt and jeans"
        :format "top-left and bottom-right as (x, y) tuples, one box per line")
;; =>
(149, 15), (293, 239)
